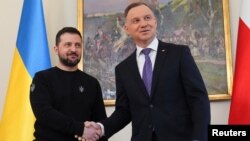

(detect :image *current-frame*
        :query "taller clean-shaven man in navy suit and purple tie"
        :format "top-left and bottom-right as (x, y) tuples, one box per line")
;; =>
(83, 2), (211, 141)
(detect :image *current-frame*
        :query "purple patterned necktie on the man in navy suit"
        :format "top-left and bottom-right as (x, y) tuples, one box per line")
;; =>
(142, 48), (152, 95)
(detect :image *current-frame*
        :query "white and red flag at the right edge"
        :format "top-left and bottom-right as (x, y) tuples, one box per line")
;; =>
(228, 0), (250, 125)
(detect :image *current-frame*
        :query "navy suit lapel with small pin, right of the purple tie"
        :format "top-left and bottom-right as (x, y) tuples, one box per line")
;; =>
(151, 41), (167, 97)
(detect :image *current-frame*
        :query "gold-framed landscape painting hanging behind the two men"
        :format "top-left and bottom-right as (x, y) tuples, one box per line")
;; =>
(77, 0), (232, 105)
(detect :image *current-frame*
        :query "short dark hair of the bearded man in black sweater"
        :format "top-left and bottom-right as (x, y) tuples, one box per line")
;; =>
(56, 27), (82, 45)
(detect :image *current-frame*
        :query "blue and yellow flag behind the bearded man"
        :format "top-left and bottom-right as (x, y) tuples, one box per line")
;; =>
(0, 0), (51, 141)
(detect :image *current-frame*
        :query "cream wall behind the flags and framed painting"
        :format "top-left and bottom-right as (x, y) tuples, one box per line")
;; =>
(0, 0), (241, 141)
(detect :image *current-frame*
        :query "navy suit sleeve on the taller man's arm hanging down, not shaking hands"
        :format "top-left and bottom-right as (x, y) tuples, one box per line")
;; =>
(181, 47), (211, 141)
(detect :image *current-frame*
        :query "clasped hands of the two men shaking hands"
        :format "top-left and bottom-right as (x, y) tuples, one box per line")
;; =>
(75, 121), (104, 141)
